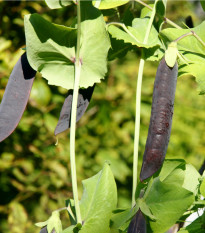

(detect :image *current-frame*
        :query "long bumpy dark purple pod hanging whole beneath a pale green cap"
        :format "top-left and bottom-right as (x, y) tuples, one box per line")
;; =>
(140, 58), (178, 181)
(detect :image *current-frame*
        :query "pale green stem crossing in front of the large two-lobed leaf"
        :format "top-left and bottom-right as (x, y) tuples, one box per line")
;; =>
(70, 0), (82, 223)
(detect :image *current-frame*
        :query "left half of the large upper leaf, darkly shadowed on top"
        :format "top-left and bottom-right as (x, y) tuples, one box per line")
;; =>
(25, 14), (76, 89)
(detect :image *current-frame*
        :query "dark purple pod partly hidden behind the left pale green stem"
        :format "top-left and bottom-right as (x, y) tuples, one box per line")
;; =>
(55, 85), (95, 135)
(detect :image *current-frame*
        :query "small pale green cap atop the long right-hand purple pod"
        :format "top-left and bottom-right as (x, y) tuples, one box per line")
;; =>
(165, 42), (178, 67)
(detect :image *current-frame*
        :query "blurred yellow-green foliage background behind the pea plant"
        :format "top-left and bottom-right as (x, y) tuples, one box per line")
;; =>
(0, 1), (205, 233)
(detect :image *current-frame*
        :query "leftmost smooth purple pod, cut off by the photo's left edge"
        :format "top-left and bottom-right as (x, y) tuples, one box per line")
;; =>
(0, 53), (36, 142)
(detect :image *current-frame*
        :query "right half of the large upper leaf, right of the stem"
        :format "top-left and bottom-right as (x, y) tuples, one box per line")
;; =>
(80, 1), (110, 88)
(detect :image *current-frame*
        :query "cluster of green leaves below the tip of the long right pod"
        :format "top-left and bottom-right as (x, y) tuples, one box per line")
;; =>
(112, 160), (200, 233)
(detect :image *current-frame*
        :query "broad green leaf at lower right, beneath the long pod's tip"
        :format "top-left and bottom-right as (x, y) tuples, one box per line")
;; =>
(143, 161), (194, 233)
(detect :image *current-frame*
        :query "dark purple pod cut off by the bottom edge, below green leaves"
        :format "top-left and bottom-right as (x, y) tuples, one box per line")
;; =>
(127, 209), (147, 233)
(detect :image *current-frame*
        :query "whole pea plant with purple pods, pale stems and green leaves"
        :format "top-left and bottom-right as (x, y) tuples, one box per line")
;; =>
(0, 0), (205, 233)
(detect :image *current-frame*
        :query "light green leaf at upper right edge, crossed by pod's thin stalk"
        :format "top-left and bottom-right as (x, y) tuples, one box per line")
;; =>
(160, 21), (205, 94)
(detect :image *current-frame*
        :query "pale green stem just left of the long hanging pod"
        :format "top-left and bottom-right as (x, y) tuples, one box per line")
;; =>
(132, 0), (155, 207)
